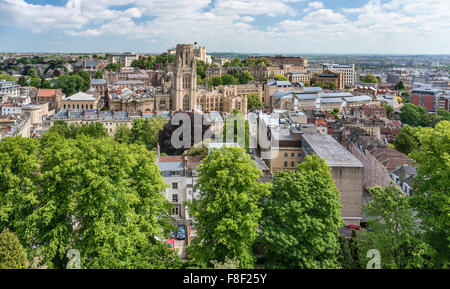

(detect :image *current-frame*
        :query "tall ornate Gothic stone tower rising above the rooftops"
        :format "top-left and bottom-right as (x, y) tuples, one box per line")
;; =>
(171, 44), (197, 111)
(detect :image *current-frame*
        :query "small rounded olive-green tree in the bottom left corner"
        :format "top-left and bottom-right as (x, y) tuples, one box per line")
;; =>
(0, 228), (28, 269)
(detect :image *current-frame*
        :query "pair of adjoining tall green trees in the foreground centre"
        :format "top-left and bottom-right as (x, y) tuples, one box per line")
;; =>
(188, 148), (343, 268)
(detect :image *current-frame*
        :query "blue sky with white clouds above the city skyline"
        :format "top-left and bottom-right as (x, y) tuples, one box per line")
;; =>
(0, 0), (450, 54)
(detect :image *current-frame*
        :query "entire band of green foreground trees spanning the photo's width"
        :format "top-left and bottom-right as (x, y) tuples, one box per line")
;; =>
(0, 120), (450, 269)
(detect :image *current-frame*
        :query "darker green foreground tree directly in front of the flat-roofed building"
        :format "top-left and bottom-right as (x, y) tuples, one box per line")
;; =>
(261, 155), (344, 269)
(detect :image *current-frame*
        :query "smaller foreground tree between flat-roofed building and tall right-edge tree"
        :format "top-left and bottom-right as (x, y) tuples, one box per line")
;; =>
(359, 185), (433, 269)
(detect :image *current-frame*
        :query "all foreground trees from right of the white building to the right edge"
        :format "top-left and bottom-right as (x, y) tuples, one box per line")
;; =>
(188, 121), (450, 269)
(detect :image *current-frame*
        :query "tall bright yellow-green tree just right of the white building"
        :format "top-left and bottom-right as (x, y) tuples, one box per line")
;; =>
(189, 148), (269, 268)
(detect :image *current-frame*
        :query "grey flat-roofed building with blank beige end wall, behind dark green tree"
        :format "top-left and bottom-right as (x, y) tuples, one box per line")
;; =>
(301, 134), (364, 225)
